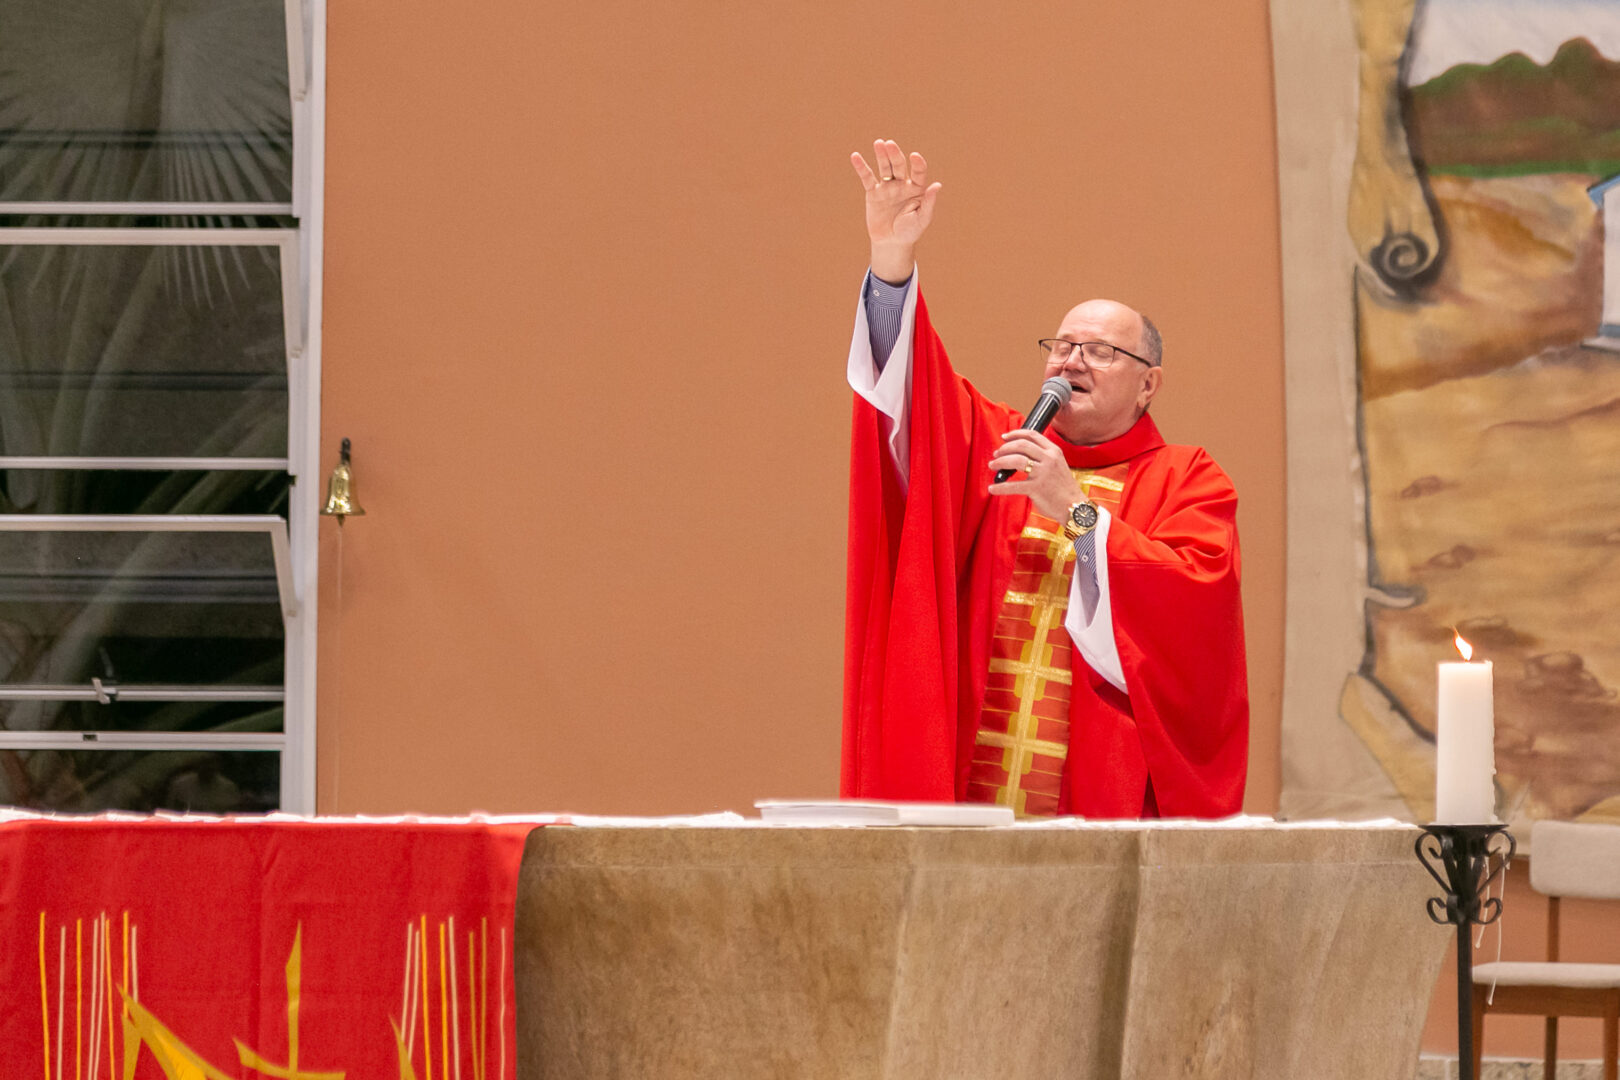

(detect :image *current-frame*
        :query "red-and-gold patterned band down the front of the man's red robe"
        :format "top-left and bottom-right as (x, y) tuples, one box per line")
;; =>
(967, 461), (1129, 818)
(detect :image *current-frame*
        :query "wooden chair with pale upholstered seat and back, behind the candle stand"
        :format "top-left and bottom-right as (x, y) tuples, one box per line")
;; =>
(1474, 821), (1620, 1080)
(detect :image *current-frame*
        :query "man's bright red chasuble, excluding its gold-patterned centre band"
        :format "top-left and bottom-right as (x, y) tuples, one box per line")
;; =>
(841, 296), (1249, 818)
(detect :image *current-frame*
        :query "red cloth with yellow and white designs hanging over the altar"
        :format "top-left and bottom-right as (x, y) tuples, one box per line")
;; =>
(0, 816), (552, 1080)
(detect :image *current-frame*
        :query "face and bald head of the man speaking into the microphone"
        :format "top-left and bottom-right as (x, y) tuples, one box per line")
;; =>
(1047, 300), (1163, 447)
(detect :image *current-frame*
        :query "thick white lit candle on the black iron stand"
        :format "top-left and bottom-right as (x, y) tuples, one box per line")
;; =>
(1434, 638), (1497, 824)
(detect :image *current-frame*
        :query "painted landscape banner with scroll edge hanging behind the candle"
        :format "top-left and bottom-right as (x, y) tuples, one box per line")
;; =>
(1273, 0), (1620, 823)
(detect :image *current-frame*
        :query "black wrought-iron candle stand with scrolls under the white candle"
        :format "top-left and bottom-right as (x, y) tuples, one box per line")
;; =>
(1416, 824), (1518, 1080)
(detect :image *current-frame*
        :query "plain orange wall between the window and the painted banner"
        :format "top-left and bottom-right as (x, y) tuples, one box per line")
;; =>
(318, 0), (1283, 813)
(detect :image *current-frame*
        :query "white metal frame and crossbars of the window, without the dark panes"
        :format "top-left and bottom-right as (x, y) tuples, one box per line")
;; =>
(0, 0), (327, 814)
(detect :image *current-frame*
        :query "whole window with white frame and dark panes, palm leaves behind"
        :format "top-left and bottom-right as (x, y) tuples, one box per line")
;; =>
(0, 0), (324, 813)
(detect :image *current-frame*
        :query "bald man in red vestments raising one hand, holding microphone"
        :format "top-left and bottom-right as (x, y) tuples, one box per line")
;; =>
(842, 139), (1249, 818)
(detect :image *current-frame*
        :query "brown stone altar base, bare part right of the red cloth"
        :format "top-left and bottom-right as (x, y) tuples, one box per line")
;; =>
(514, 823), (1447, 1080)
